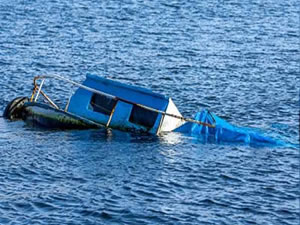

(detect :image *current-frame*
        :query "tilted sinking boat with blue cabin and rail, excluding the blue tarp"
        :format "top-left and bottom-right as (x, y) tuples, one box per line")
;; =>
(4, 74), (214, 134)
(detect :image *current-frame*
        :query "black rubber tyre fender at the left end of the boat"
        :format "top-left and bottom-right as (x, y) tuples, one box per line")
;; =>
(3, 97), (29, 120)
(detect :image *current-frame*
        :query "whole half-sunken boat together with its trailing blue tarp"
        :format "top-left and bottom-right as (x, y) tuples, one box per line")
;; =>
(3, 74), (282, 145)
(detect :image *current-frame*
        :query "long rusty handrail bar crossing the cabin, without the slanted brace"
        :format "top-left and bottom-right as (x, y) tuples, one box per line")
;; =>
(32, 75), (216, 128)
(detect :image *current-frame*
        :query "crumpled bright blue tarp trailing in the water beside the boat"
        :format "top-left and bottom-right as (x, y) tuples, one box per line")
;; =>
(175, 110), (283, 146)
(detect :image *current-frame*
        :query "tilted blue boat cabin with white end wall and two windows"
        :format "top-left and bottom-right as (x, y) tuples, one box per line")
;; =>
(67, 74), (184, 134)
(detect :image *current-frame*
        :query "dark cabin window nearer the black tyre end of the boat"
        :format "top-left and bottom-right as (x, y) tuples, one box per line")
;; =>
(90, 93), (117, 115)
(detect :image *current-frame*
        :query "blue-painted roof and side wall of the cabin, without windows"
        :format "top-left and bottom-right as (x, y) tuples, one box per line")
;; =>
(68, 74), (169, 134)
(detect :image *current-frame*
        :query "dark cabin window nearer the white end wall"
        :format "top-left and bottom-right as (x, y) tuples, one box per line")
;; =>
(129, 105), (158, 128)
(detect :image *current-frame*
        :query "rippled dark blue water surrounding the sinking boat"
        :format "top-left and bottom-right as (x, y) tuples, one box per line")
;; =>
(0, 0), (300, 225)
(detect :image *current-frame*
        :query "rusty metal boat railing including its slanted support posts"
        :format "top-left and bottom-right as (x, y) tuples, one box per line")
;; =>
(30, 75), (216, 128)
